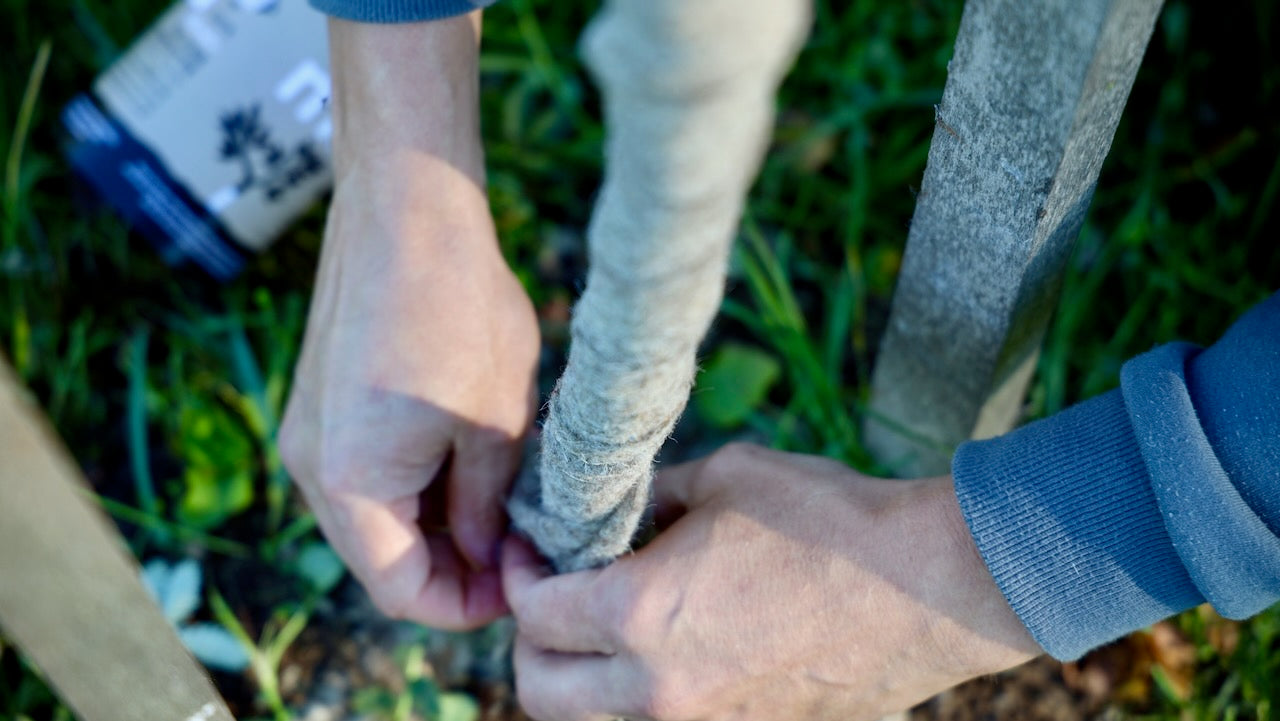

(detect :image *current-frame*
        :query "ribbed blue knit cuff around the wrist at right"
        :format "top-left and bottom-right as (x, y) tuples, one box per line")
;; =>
(952, 391), (1203, 661)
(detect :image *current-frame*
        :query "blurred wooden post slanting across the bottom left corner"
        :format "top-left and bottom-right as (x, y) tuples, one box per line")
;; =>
(0, 360), (232, 721)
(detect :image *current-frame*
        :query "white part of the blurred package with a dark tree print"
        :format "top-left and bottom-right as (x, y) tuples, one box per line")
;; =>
(85, 0), (333, 258)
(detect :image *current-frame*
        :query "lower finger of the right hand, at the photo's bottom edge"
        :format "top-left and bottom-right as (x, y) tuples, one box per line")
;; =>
(512, 633), (634, 721)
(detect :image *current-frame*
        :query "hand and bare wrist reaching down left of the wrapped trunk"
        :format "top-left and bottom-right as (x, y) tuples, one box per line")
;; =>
(280, 18), (539, 629)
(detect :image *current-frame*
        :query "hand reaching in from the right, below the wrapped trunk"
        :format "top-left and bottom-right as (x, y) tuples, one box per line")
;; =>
(503, 446), (1039, 721)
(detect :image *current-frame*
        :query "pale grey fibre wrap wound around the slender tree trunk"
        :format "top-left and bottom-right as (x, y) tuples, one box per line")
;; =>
(509, 0), (810, 572)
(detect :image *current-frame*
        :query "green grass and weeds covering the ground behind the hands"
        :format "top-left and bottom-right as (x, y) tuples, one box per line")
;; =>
(0, 0), (1280, 720)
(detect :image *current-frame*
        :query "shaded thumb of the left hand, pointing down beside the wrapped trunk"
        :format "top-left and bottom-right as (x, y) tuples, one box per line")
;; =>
(448, 430), (522, 567)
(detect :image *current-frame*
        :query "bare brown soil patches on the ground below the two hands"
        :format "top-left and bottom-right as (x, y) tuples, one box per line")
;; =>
(244, 580), (1161, 721)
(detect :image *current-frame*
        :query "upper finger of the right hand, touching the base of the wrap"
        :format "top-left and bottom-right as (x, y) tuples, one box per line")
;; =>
(502, 537), (617, 654)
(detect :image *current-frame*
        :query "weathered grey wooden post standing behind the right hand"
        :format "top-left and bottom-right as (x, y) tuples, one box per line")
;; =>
(865, 0), (1162, 476)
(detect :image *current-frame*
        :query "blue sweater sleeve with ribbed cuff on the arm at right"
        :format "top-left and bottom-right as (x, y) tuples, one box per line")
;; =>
(952, 293), (1280, 660)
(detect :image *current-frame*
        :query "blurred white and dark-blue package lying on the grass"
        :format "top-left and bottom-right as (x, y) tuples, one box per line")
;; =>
(63, 0), (333, 279)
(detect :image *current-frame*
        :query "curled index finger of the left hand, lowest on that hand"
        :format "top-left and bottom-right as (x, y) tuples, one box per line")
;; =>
(329, 496), (506, 630)
